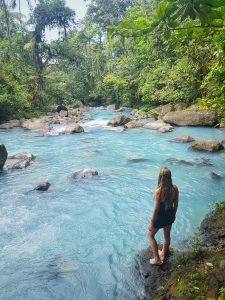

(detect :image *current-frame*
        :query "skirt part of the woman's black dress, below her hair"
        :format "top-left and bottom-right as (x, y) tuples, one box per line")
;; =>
(153, 202), (175, 228)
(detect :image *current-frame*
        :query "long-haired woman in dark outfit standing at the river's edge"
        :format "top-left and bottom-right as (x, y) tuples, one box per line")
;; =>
(147, 168), (179, 265)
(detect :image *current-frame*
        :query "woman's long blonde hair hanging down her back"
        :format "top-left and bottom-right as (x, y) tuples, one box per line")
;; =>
(158, 167), (173, 208)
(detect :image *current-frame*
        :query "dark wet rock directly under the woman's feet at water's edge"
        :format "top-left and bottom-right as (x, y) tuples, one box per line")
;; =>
(136, 248), (176, 300)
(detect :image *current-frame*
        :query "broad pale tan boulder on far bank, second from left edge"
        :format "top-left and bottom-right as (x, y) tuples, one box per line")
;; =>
(22, 117), (51, 133)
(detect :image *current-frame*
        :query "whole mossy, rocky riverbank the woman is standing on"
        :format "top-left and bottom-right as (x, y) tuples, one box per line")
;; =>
(138, 202), (225, 300)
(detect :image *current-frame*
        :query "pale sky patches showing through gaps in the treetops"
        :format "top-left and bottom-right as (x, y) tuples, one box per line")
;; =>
(17, 0), (88, 40)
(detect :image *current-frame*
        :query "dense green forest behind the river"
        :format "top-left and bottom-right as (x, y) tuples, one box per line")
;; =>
(0, 0), (225, 121)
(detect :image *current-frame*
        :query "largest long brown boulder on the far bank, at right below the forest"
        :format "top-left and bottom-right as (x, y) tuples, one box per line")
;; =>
(163, 109), (217, 126)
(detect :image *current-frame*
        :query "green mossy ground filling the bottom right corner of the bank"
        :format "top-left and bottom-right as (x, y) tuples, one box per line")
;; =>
(155, 248), (225, 300)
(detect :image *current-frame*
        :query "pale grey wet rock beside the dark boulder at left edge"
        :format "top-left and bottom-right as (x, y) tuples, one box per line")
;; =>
(4, 152), (35, 170)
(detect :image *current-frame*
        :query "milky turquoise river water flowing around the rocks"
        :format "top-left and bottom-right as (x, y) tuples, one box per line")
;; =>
(0, 109), (225, 300)
